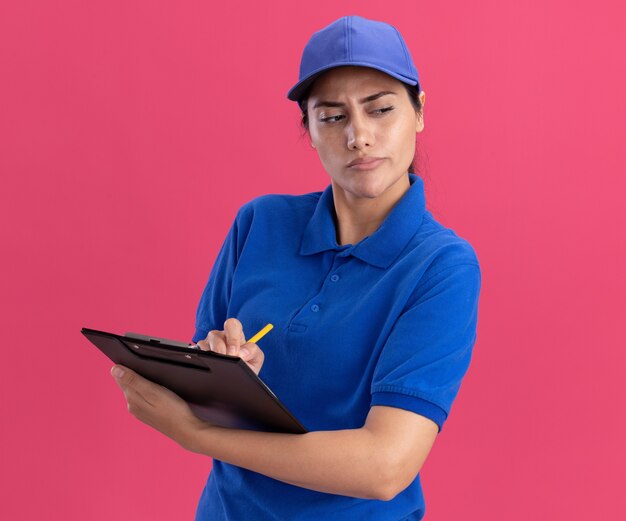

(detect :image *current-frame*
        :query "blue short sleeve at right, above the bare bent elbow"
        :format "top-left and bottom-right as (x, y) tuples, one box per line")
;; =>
(371, 263), (481, 431)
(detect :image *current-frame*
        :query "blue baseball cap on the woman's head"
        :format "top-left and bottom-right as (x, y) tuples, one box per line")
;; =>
(287, 16), (420, 101)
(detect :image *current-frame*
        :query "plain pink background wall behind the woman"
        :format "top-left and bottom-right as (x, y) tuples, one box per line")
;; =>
(0, 0), (626, 521)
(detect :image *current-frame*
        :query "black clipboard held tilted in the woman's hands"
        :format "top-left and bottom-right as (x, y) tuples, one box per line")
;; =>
(81, 328), (307, 434)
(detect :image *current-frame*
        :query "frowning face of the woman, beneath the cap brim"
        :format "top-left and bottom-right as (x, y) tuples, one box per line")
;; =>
(307, 67), (424, 204)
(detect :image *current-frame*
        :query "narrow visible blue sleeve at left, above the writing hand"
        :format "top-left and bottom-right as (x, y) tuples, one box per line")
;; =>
(192, 213), (239, 342)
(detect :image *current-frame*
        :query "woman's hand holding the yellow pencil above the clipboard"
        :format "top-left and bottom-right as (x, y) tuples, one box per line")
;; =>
(198, 318), (265, 375)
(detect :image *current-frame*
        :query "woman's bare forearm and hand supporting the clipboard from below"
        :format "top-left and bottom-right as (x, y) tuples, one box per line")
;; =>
(109, 366), (438, 500)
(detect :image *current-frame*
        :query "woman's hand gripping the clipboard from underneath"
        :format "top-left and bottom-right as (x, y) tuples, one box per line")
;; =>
(111, 365), (210, 450)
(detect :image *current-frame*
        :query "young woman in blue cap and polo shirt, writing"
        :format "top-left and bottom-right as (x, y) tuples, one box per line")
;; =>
(113, 16), (481, 521)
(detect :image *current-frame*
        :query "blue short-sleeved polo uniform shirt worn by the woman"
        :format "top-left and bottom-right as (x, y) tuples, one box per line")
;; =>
(193, 174), (481, 521)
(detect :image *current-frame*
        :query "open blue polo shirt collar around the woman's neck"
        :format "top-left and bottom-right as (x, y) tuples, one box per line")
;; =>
(300, 173), (426, 268)
